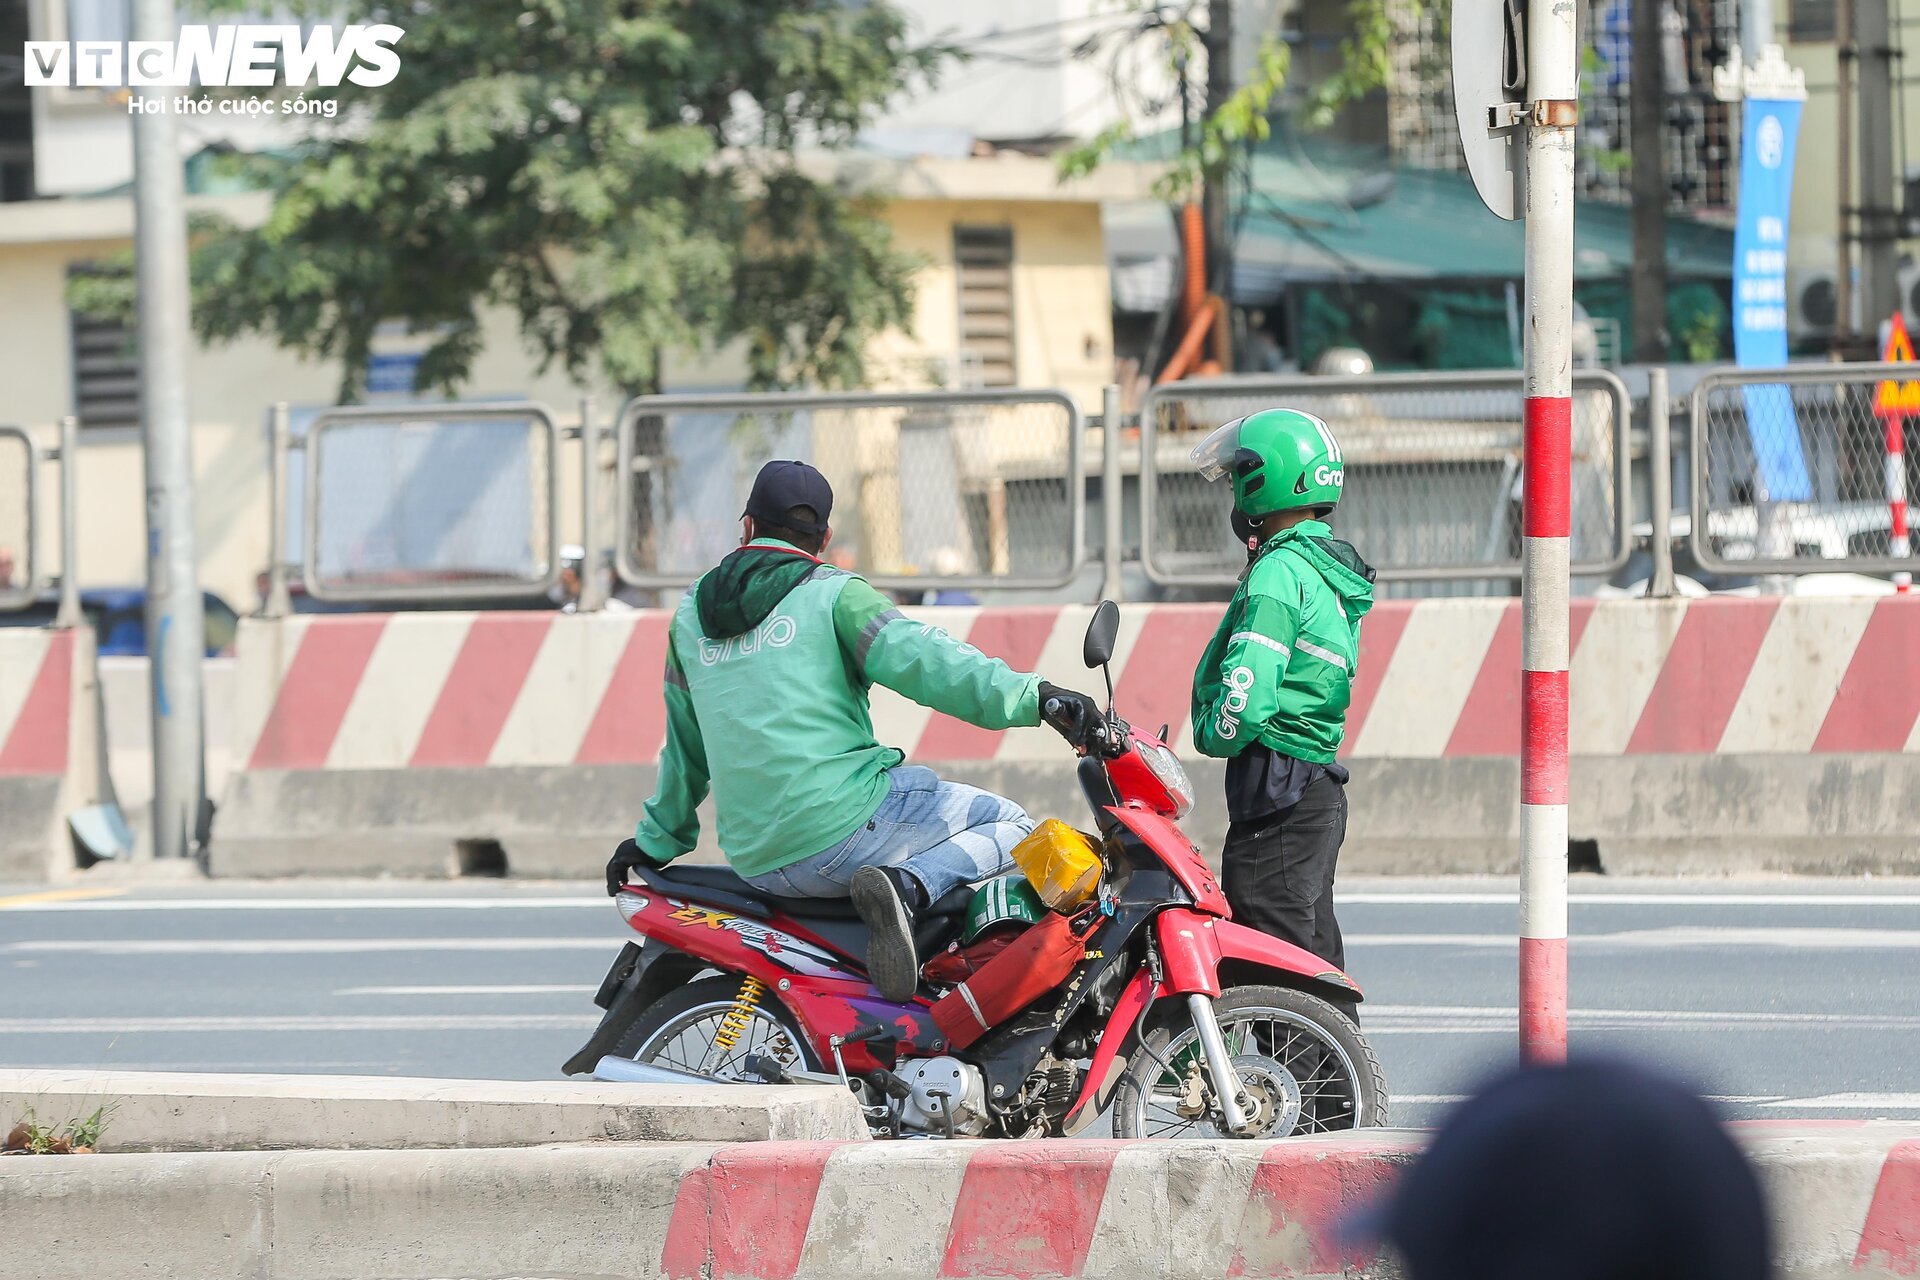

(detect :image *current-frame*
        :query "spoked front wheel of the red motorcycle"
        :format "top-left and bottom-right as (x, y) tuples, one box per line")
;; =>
(1114, 986), (1386, 1138)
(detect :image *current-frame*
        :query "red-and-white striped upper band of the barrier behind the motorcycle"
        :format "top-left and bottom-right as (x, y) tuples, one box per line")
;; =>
(228, 597), (1920, 771)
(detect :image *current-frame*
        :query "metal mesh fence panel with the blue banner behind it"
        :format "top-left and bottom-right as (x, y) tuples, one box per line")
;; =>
(1692, 365), (1920, 574)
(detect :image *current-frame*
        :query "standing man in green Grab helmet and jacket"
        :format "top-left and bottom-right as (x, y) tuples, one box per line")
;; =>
(1192, 409), (1373, 967)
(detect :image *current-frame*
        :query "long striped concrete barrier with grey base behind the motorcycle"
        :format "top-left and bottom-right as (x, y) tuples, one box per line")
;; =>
(211, 597), (1920, 875)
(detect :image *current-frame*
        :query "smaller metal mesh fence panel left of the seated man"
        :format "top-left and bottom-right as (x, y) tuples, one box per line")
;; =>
(303, 405), (561, 601)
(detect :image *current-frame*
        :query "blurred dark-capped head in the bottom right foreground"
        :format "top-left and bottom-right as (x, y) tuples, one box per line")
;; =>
(1369, 1059), (1772, 1280)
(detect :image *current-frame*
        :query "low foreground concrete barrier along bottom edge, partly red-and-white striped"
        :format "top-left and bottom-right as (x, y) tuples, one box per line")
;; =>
(0, 1125), (1920, 1280)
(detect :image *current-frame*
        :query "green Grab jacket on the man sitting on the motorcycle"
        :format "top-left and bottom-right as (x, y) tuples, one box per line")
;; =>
(634, 539), (1041, 875)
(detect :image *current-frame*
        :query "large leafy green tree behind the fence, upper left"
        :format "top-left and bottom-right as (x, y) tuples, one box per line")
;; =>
(88, 0), (948, 399)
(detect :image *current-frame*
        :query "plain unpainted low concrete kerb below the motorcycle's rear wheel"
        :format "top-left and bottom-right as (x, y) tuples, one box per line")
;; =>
(0, 1069), (866, 1151)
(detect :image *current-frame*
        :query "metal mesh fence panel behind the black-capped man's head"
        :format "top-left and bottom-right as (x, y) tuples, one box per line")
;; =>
(618, 390), (1087, 589)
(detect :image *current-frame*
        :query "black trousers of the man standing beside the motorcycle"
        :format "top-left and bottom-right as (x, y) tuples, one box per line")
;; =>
(1221, 777), (1346, 969)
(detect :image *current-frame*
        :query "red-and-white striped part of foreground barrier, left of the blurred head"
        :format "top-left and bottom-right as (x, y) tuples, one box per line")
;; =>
(639, 1132), (1419, 1280)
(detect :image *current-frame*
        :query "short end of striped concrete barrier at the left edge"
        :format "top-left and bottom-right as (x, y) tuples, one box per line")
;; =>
(0, 628), (111, 881)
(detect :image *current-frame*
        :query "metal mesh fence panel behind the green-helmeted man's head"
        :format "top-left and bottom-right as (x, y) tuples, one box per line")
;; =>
(1140, 370), (1628, 593)
